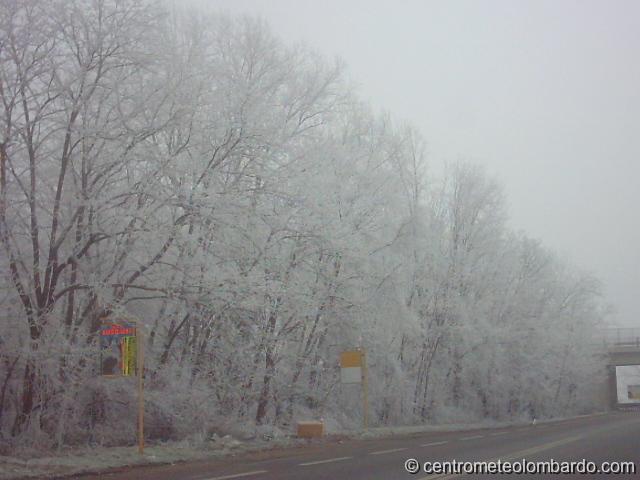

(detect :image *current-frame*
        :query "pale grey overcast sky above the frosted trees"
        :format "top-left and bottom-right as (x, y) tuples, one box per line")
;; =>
(194, 0), (640, 326)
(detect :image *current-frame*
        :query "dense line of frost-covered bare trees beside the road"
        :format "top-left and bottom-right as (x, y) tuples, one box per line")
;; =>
(0, 0), (602, 447)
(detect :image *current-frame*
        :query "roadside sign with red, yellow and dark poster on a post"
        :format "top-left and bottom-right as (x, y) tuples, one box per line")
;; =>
(100, 322), (144, 455)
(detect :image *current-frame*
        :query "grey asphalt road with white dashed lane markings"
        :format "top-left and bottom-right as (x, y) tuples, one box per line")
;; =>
(71, 412), (640, 480)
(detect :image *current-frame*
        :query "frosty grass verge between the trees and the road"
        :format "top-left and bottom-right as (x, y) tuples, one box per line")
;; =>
(0, 413), (602, 480)
